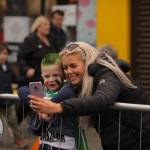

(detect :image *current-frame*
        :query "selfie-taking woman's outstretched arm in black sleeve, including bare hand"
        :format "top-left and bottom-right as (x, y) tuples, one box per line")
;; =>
(30, 73), (122, 116)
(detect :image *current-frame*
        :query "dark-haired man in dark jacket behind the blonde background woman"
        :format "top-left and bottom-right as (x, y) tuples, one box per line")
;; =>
(49, 10), (67, 53)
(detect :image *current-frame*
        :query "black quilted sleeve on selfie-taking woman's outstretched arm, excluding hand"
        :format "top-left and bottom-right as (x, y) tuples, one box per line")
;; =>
(61, 71), (122, 116)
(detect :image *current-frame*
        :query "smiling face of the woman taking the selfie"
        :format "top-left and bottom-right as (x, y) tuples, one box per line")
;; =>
(62, 54), (85, 85)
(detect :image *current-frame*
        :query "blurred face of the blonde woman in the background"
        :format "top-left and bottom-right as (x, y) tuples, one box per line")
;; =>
(37, 21), (50, 35)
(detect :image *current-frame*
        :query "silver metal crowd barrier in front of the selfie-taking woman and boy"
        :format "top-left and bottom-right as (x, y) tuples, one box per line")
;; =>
(0, 94), (150, 150)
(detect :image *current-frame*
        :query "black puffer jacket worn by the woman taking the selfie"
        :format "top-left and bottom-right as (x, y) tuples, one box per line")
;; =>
(61, 61), (150, 150)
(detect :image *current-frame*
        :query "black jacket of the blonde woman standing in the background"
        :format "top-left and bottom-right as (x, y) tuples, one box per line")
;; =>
(18, 32), (54, 86)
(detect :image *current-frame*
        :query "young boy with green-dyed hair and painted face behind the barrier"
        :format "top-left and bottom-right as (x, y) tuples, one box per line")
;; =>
(18, 53), (76, 150)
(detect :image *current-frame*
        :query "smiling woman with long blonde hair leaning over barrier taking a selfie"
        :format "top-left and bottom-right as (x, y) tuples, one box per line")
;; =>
(24, 42), (150, 150)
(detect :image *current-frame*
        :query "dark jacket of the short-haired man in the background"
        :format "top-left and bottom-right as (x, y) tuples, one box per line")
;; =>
(49, 24), (67, 53)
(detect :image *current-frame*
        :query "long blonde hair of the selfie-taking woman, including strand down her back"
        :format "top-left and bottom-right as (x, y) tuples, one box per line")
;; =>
(60, 42), (136, 128)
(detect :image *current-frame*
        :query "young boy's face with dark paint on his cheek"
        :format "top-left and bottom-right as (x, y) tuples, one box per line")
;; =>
(41, 64), (64, 91)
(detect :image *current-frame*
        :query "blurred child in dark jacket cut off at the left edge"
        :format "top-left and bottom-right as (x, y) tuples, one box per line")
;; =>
(0, 43), (28, 148)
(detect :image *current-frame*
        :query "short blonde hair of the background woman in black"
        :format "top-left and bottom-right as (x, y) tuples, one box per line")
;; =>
(30, 15), (50, 32)
